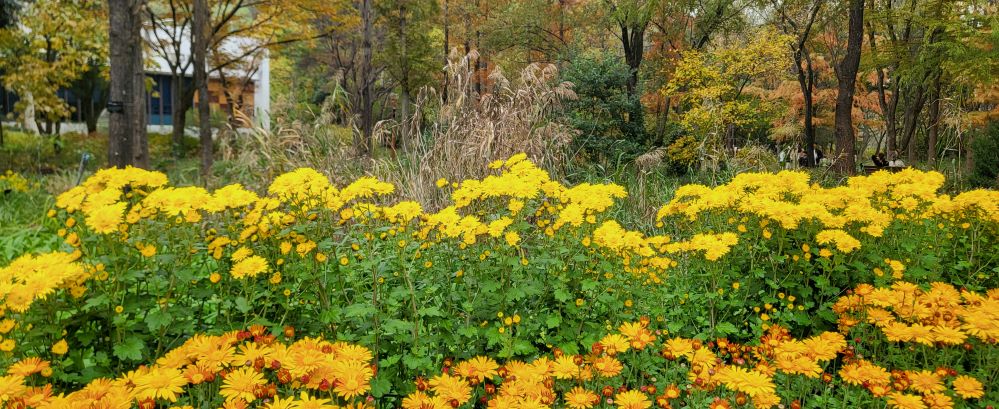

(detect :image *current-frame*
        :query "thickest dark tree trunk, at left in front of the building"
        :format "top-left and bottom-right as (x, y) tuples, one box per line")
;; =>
(108, 0), (149, 168)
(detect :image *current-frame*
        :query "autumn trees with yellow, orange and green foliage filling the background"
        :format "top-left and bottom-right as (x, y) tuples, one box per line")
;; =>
(0, 0), (999, 179)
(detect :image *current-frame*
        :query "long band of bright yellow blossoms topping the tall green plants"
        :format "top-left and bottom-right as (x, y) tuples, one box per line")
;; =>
(57, 154), (999, 292)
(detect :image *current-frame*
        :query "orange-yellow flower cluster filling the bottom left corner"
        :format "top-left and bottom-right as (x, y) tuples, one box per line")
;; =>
(0, 327), (374, 409)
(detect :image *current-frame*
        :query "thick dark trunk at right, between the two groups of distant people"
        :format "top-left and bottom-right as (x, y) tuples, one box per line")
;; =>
(835, 0), (864, 174)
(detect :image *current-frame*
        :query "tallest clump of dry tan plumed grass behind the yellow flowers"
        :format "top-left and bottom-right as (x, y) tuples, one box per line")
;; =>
(390, 52), (576, 206)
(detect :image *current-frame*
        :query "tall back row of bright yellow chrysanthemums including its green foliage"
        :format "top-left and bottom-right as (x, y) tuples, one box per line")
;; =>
(0, 155), (999, 402)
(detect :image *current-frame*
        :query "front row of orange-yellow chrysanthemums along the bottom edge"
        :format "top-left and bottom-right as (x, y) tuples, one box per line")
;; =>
(0, 282), (999, 409)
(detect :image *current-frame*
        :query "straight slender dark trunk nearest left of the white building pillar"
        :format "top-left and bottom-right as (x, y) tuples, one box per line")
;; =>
(195, 0), (214, 177)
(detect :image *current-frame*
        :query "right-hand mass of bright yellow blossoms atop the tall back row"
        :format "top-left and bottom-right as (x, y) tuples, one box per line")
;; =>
(657, 169), (999, 244)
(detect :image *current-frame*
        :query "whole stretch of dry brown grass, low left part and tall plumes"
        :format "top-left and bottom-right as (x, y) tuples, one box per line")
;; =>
(219, 51), (576, 208)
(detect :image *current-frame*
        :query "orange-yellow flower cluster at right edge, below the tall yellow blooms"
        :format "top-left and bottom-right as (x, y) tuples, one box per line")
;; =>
(833, 281), (999, 346)
